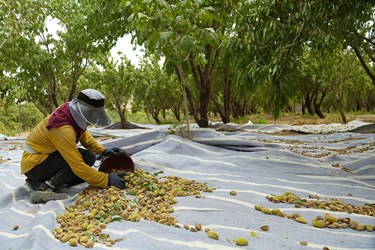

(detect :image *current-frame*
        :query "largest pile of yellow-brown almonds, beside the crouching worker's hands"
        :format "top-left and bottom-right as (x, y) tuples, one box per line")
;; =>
(54, 169), (213, 248)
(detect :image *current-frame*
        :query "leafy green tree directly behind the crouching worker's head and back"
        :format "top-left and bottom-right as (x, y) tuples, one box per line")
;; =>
(0, 1), (109, 115)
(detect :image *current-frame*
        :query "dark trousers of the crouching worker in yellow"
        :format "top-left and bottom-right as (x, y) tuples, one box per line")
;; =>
(25, 148), (96, 188)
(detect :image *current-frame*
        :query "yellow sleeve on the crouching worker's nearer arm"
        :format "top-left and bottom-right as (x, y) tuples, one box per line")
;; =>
(48, 125), (108, 188)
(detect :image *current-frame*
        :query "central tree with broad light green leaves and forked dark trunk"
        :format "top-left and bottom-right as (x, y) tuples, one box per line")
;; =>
(101, 0), (238, 127)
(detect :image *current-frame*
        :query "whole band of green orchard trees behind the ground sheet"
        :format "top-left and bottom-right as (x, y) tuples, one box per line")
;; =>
(0, 0), (375, 134)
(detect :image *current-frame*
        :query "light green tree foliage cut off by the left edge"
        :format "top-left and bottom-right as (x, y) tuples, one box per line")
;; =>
(0, 0), (49, 103)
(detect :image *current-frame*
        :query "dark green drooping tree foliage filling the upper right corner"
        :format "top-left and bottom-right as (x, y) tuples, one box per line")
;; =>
(236, 0), (375, 117)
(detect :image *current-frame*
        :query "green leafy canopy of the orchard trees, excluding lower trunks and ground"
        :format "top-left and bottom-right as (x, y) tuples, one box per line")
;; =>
(0, 0), (375, 129)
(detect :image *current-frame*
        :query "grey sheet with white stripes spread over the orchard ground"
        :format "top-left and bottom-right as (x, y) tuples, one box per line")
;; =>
(0, 124), (375, 250)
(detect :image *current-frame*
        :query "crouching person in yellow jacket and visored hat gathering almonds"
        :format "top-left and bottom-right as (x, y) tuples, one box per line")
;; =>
(21, 89), (125, 203)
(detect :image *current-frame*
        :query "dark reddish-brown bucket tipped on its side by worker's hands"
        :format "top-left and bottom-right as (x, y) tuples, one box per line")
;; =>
(98, 153), (135, 173)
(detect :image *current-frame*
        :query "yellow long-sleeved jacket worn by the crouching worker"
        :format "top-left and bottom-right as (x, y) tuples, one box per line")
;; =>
(21, 116), (108, 188)
